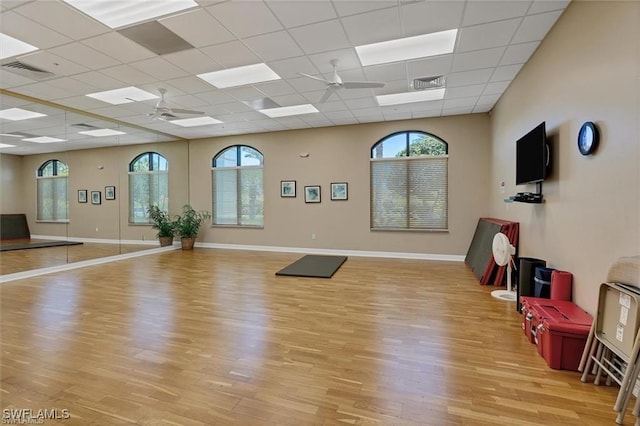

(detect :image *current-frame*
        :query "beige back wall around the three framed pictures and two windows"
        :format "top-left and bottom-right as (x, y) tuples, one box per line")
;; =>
(189, 114), (490, 255)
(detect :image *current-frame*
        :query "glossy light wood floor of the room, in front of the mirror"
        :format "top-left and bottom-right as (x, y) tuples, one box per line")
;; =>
(0, 248), (634, 426)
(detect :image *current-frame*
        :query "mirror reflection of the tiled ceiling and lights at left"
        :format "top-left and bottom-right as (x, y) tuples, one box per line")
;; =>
(0, 94), (177, 155)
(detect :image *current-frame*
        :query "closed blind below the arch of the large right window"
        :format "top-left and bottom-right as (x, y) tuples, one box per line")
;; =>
(371, 155), (448, 230)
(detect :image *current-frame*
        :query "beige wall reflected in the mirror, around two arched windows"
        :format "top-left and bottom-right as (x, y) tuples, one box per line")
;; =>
(20, 142), (189, 240)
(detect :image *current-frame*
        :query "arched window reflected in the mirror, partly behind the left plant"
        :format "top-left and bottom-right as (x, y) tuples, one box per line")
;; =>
(129, 152), (169, 223)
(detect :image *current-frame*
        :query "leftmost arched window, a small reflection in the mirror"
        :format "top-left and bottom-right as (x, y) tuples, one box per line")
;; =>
(36, 160), (69, 222)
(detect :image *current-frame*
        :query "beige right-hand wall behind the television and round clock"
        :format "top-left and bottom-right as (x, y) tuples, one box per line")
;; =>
(490, 1), (640, 313)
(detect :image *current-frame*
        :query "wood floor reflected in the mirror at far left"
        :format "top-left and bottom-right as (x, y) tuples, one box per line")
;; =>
(0, 239), (152, 275)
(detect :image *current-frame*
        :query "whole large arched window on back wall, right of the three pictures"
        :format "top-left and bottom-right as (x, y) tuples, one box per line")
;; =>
(371, 131), (449, 231)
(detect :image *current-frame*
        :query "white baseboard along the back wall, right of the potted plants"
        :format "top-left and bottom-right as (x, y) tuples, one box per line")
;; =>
(196, 242), (465, 262)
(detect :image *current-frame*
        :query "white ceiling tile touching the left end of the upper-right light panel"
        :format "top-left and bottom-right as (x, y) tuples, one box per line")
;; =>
(289, 19), (350, 54)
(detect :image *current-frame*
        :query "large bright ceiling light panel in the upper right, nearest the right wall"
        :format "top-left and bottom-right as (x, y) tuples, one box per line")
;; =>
(356, 29), (458, 66)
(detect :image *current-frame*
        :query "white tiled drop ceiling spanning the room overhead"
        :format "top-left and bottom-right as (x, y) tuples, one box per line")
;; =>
(0, 0), (569, 153)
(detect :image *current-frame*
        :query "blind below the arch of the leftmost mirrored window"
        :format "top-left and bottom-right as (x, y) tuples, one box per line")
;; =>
(36, 176), (69, 221)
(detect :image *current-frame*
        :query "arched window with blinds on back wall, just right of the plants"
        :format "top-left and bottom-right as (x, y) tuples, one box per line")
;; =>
(211, 145), (264, 227)
